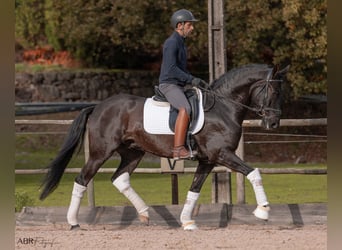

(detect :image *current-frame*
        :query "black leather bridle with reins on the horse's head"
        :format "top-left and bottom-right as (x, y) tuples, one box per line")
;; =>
(201, 69), (283, 117)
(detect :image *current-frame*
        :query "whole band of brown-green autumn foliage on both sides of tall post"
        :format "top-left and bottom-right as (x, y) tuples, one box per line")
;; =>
(15, 0), (327, 98)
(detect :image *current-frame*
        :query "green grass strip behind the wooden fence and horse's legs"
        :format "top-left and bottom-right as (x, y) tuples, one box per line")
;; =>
(15, 149), (327, 206)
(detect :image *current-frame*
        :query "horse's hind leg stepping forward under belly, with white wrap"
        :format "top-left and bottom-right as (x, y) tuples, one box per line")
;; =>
(112, 149), (149, 224)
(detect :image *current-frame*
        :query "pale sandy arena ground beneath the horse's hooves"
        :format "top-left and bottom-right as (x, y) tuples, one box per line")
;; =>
(15, 224), (327, 250)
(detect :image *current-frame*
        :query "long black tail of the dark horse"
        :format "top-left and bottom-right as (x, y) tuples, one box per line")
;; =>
(39, 106), (95, 200)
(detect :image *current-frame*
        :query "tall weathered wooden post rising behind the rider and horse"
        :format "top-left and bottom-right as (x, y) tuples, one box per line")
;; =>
(208, 0), (232, 204)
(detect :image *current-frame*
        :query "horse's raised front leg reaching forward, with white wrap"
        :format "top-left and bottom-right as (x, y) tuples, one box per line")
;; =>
(218, 151), (270, 220)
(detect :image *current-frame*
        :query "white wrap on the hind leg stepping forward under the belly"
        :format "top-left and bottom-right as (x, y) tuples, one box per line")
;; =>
(113, 172), (149, 217)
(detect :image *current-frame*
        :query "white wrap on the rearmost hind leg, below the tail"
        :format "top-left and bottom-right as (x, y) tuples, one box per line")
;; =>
(67, 182), (87, 226)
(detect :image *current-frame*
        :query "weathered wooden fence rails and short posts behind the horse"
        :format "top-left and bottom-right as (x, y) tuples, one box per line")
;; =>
(15, 118), (327, 207)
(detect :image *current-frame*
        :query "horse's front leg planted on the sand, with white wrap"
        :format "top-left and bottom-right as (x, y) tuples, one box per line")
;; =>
(180, 162), (214, 230)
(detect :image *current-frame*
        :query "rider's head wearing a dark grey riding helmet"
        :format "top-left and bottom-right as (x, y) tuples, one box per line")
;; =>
(171, 9), (198, 37)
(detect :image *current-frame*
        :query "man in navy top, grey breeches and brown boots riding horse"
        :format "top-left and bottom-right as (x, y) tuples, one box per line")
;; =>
(159, 9), (205, 159)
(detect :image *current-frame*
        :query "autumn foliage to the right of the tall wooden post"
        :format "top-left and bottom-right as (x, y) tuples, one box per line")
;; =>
(227, 0), (327, 98)
